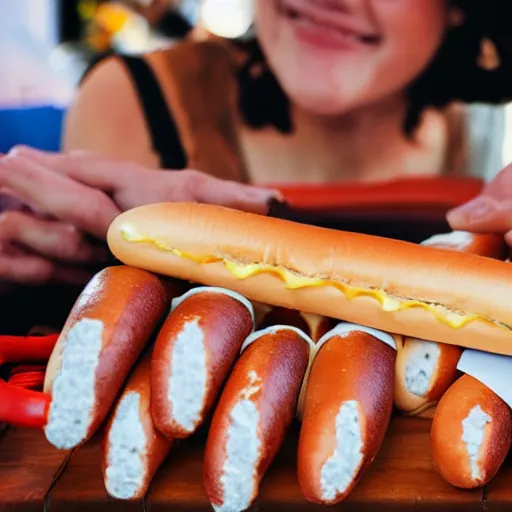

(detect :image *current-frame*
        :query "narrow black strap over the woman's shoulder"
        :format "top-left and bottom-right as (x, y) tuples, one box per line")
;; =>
(119, 55), (187, 169)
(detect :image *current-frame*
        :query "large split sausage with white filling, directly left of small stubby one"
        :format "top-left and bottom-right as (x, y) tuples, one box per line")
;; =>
(297, 324), (396, 504)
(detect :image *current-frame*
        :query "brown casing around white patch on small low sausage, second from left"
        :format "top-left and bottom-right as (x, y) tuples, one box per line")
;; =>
(102, 351), (172, 500)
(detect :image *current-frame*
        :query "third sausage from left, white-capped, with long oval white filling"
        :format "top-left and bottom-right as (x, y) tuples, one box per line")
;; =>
(151, 287), (254, 438)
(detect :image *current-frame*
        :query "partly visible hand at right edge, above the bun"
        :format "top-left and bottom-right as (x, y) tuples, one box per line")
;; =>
(447, 164), (512, 246)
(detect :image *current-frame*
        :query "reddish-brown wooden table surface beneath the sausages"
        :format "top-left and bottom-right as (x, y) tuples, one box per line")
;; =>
(0, 418), (512, 512)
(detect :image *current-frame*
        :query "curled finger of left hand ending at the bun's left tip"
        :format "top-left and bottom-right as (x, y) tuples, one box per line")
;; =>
(0, 211), (108, 264)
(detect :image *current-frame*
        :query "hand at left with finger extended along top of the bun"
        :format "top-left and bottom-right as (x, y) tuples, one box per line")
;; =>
(0, 147), (276, 283)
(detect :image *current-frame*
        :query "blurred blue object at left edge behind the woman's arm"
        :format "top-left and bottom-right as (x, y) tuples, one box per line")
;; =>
(0, 105), (66, 153)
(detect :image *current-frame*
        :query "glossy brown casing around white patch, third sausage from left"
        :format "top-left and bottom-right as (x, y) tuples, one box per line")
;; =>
(151, 292), (253, 439)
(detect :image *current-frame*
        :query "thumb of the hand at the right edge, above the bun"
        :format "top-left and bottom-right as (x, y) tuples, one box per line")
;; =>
(447, 196), (512, 233)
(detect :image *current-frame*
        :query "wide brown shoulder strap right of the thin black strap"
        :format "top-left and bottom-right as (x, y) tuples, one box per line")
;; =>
(148, 40), (248, 181)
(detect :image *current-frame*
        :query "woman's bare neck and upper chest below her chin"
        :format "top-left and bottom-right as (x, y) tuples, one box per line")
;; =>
(241, 93), (448, 183)
